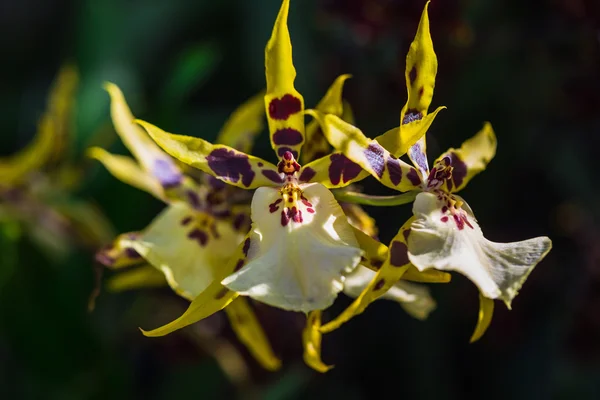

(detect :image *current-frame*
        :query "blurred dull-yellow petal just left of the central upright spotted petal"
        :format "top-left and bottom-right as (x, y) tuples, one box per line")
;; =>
(215, 93), (265, 153)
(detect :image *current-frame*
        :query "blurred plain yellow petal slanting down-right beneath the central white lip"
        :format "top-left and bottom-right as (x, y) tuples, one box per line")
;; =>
(225, 297), (281, 371)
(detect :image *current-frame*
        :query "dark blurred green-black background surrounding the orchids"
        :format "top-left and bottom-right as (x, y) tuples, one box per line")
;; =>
(0, 0), (600, 400)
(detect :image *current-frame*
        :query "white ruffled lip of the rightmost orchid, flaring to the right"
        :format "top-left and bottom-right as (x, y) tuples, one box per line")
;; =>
(408, 193), (552, 308)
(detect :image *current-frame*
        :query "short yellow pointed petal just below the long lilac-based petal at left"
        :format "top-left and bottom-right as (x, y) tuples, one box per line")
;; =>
(87, 147), (163, 199)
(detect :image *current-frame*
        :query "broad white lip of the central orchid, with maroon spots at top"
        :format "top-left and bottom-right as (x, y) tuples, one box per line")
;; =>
(223, 184), (361, 313)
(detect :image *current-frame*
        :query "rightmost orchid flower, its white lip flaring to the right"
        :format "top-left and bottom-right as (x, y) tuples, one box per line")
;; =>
(310, 2), (552, 342)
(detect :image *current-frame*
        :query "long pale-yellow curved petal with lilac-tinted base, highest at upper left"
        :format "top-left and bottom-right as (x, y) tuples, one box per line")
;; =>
(104, 83), (183, 189)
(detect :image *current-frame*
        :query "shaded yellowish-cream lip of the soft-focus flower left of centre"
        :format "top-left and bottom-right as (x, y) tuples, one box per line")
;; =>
(124, 203), (243, 300)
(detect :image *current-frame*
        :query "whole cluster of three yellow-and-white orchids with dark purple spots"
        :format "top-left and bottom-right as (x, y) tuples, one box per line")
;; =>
(83, 0), (551, 372)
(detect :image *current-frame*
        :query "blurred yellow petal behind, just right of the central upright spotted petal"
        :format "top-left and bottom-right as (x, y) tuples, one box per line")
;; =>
(300, 74), (353, 164)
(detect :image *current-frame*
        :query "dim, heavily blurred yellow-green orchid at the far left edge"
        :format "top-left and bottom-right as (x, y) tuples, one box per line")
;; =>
(0, 65), (112, 256)
